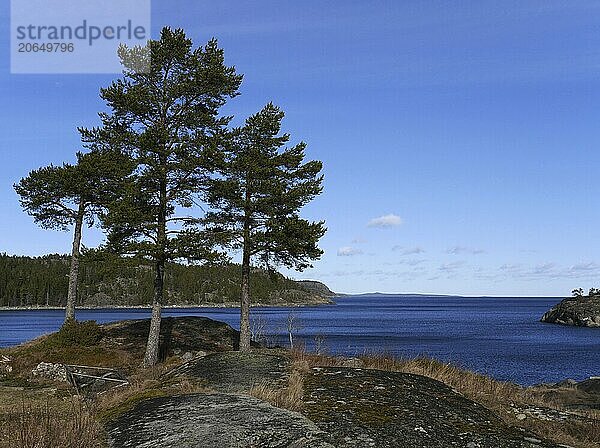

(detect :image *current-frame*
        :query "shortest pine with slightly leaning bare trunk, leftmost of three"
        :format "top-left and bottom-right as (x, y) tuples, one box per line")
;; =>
(14, 151), (127, 321)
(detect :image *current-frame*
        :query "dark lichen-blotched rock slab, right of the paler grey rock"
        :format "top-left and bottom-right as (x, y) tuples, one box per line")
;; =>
(302, 367), (558, 448)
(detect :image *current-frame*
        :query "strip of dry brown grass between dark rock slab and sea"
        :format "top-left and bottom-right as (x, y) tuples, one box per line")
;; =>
(293, 350), (600, 448)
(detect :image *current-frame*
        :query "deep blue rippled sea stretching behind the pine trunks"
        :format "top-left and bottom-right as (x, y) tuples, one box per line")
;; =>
(0, 295), (600, 385)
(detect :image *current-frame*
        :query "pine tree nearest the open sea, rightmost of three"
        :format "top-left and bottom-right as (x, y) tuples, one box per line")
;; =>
(204, 103), (326, 351)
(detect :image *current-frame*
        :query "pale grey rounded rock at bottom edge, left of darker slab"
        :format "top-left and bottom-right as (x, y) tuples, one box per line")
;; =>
(107, 393), (333, 448)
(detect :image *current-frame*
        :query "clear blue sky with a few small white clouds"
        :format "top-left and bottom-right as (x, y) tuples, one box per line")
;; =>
(0, 0), (600, 295)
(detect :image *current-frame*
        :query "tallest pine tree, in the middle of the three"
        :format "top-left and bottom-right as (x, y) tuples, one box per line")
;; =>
(81, 28), (242, 366)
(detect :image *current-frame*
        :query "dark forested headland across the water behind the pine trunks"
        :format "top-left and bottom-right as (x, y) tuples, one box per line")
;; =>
(0, 254), (328, 306)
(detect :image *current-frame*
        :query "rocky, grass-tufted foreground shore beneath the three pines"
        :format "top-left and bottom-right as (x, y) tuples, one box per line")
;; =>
(0, 317), (600, 448)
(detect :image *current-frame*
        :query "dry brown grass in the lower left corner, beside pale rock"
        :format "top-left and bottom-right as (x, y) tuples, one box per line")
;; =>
(0, 359), (206, 448)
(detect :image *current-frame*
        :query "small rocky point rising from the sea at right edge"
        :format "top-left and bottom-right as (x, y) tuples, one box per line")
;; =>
(541, 296), (600, 327)
